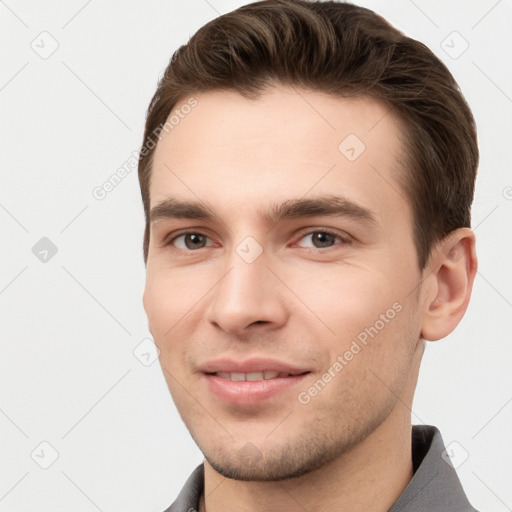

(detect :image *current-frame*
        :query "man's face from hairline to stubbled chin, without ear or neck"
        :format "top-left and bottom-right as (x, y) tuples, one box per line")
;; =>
(144, 87), (425, 480)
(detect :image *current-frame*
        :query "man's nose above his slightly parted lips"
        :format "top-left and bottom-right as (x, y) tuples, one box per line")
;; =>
(207, 253), (288, 337)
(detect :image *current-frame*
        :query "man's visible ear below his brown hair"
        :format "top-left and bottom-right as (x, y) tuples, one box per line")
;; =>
(421, 228), (477, 341)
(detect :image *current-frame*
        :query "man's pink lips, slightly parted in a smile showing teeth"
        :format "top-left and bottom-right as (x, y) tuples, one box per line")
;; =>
(200, 358), (310, 406)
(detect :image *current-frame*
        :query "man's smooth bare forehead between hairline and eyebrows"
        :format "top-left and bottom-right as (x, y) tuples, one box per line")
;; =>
(150, 87), (407, 223)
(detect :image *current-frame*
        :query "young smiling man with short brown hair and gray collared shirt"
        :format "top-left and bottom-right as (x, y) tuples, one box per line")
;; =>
(139, 0), (478, 512)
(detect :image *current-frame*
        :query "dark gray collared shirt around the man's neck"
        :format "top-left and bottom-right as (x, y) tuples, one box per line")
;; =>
(165, 425), (476, 512)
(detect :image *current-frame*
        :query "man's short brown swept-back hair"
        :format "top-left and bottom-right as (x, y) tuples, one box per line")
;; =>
(139, 0), (478, 269)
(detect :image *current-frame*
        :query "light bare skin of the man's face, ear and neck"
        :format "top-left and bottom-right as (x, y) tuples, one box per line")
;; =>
(144, 86), (476, 512)
